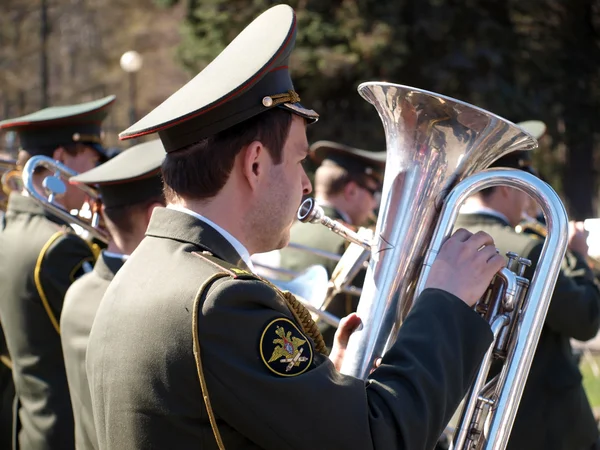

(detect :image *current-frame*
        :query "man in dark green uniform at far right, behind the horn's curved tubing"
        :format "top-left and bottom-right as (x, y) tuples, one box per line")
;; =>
(456, 152), (600, 450)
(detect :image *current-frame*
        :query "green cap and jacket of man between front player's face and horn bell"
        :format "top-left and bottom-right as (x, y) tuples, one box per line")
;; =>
(280, 141), (386, 347)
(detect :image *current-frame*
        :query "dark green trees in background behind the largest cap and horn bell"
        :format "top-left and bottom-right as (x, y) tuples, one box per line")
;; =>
(164, 0), (600, 218)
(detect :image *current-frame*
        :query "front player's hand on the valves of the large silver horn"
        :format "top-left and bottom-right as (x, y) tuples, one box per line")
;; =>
(425, 228), (506, 306)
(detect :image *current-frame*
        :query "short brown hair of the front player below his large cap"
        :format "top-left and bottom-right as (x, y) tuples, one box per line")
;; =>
(162, 108), (292, 202)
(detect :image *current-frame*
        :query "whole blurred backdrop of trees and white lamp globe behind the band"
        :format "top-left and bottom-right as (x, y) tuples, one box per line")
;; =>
(0, 0), (600, 414)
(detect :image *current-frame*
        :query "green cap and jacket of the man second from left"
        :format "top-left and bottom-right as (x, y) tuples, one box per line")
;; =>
(60, 139), (165, 450)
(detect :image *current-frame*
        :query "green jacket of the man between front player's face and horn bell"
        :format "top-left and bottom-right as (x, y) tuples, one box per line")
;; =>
(281, 206), (365, 346)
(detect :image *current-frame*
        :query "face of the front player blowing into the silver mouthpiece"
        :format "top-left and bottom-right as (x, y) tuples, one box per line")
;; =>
(256, 115), (312, 251)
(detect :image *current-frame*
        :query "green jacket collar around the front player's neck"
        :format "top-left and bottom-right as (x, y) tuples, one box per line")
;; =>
(146, 207), (250, 270)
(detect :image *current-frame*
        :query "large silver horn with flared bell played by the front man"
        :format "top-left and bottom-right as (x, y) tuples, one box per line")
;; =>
(298, 82), (567, 450)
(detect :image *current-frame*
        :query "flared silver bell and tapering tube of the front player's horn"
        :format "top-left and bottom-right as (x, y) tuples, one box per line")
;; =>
(342, 83), (537, 378)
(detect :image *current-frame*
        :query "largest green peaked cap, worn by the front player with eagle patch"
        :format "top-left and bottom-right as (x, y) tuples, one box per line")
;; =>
(119, 5), (319, 153)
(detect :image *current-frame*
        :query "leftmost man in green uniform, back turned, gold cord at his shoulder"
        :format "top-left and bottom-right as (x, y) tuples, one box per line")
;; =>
(0, 96), (115, 450)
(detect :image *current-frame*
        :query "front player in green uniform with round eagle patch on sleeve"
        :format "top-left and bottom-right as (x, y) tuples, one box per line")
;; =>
(87, 5), (503, 450)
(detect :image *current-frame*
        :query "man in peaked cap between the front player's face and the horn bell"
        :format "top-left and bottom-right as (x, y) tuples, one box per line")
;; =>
(280, 141), (386, 347)
